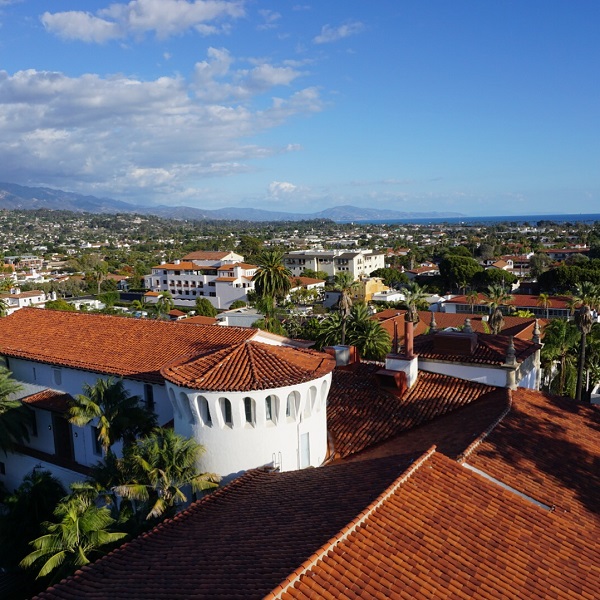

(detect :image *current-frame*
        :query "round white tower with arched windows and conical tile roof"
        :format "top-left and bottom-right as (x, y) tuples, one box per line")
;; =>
(161, 341), (335, 480)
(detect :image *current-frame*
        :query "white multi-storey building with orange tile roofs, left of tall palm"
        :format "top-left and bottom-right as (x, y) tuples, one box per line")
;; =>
(144, 252), (258, 309)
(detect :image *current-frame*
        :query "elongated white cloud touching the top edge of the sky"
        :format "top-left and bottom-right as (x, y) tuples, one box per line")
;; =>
(41, 0), (245, 43)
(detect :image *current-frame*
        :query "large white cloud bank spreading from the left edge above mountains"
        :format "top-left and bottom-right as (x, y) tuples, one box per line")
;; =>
(0, 50), (323, 203)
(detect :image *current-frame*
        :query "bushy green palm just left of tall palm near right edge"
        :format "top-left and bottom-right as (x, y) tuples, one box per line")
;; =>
(542, 319), (579, 396)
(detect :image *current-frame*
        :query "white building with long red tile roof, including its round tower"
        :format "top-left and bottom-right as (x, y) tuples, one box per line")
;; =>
(0, 309), (335, 489)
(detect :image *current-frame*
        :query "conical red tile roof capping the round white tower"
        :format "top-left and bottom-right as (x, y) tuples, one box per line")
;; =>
(161, 341), (335, 392)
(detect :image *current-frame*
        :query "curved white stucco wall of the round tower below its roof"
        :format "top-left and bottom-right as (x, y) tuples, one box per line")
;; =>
(167, 374), (331, 480)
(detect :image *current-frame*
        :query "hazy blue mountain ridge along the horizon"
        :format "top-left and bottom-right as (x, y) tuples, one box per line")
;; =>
(0, 182), (464, 222)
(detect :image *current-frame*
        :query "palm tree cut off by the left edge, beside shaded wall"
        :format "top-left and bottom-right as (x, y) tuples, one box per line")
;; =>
(0, 367), (33, 454)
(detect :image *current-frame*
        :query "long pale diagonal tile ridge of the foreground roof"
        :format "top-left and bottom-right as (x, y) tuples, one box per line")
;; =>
(263, 446), (436, 600)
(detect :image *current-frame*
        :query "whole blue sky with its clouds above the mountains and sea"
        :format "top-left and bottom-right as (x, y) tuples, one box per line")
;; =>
(0, 0), (600, 216)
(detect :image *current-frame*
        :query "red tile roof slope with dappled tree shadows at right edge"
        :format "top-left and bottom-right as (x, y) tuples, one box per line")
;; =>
(465, 388), (600, 534)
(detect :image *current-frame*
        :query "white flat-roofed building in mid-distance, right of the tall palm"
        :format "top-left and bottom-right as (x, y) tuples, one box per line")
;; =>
(283, 250), (385, 279)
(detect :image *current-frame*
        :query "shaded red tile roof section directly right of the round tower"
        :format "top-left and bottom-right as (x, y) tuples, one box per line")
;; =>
(327, 363), (497, 457)
